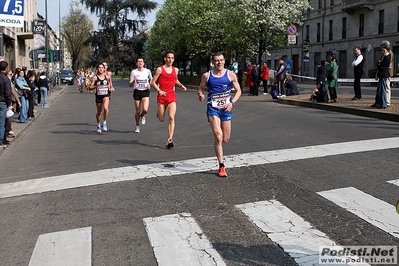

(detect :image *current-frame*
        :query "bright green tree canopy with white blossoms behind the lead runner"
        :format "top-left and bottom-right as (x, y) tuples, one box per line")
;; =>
(146, 0), (309, 69)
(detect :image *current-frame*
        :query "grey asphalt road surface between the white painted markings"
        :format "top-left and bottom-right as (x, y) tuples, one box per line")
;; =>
(0, 80), (399, 265)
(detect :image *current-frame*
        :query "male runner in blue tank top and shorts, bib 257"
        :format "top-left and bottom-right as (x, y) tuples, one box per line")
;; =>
(198, 53), (241, 177)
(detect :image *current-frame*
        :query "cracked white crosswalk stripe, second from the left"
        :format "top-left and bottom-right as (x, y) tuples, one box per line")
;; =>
(143, 213), (225, 266)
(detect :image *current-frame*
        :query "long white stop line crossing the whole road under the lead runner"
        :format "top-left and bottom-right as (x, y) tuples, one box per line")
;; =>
(0, 137), (399, 198)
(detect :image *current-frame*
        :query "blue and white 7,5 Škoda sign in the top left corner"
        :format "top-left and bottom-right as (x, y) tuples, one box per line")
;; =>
(0, 0), (24, 28)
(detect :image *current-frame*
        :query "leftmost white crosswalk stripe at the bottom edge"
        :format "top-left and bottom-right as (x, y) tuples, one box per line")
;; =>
(29, 227), (91, 266)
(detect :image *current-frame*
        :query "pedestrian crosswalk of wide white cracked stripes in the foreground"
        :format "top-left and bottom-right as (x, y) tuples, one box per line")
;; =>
(29, 183), (399, 266)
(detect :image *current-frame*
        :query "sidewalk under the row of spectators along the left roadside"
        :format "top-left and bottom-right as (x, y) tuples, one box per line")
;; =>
(0, 85), (68, 152)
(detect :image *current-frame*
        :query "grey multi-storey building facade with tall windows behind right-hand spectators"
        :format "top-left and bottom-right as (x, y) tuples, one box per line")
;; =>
(267, 0), (399, 78)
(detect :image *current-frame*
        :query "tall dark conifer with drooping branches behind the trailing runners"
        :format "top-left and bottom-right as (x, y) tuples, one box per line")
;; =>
(80, 0), (157, 71)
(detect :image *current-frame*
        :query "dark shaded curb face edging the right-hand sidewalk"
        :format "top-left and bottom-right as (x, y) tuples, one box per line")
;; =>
(277, 98), (399, 122)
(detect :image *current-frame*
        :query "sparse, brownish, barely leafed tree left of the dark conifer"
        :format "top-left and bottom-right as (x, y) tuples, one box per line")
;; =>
(61, 1), (94, 70)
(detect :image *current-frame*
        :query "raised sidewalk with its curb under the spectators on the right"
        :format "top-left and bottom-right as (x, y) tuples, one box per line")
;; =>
(277, 83), (399, 122)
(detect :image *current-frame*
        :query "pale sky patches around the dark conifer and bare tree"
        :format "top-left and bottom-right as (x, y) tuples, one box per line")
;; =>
(37, 0), (164, 30)
